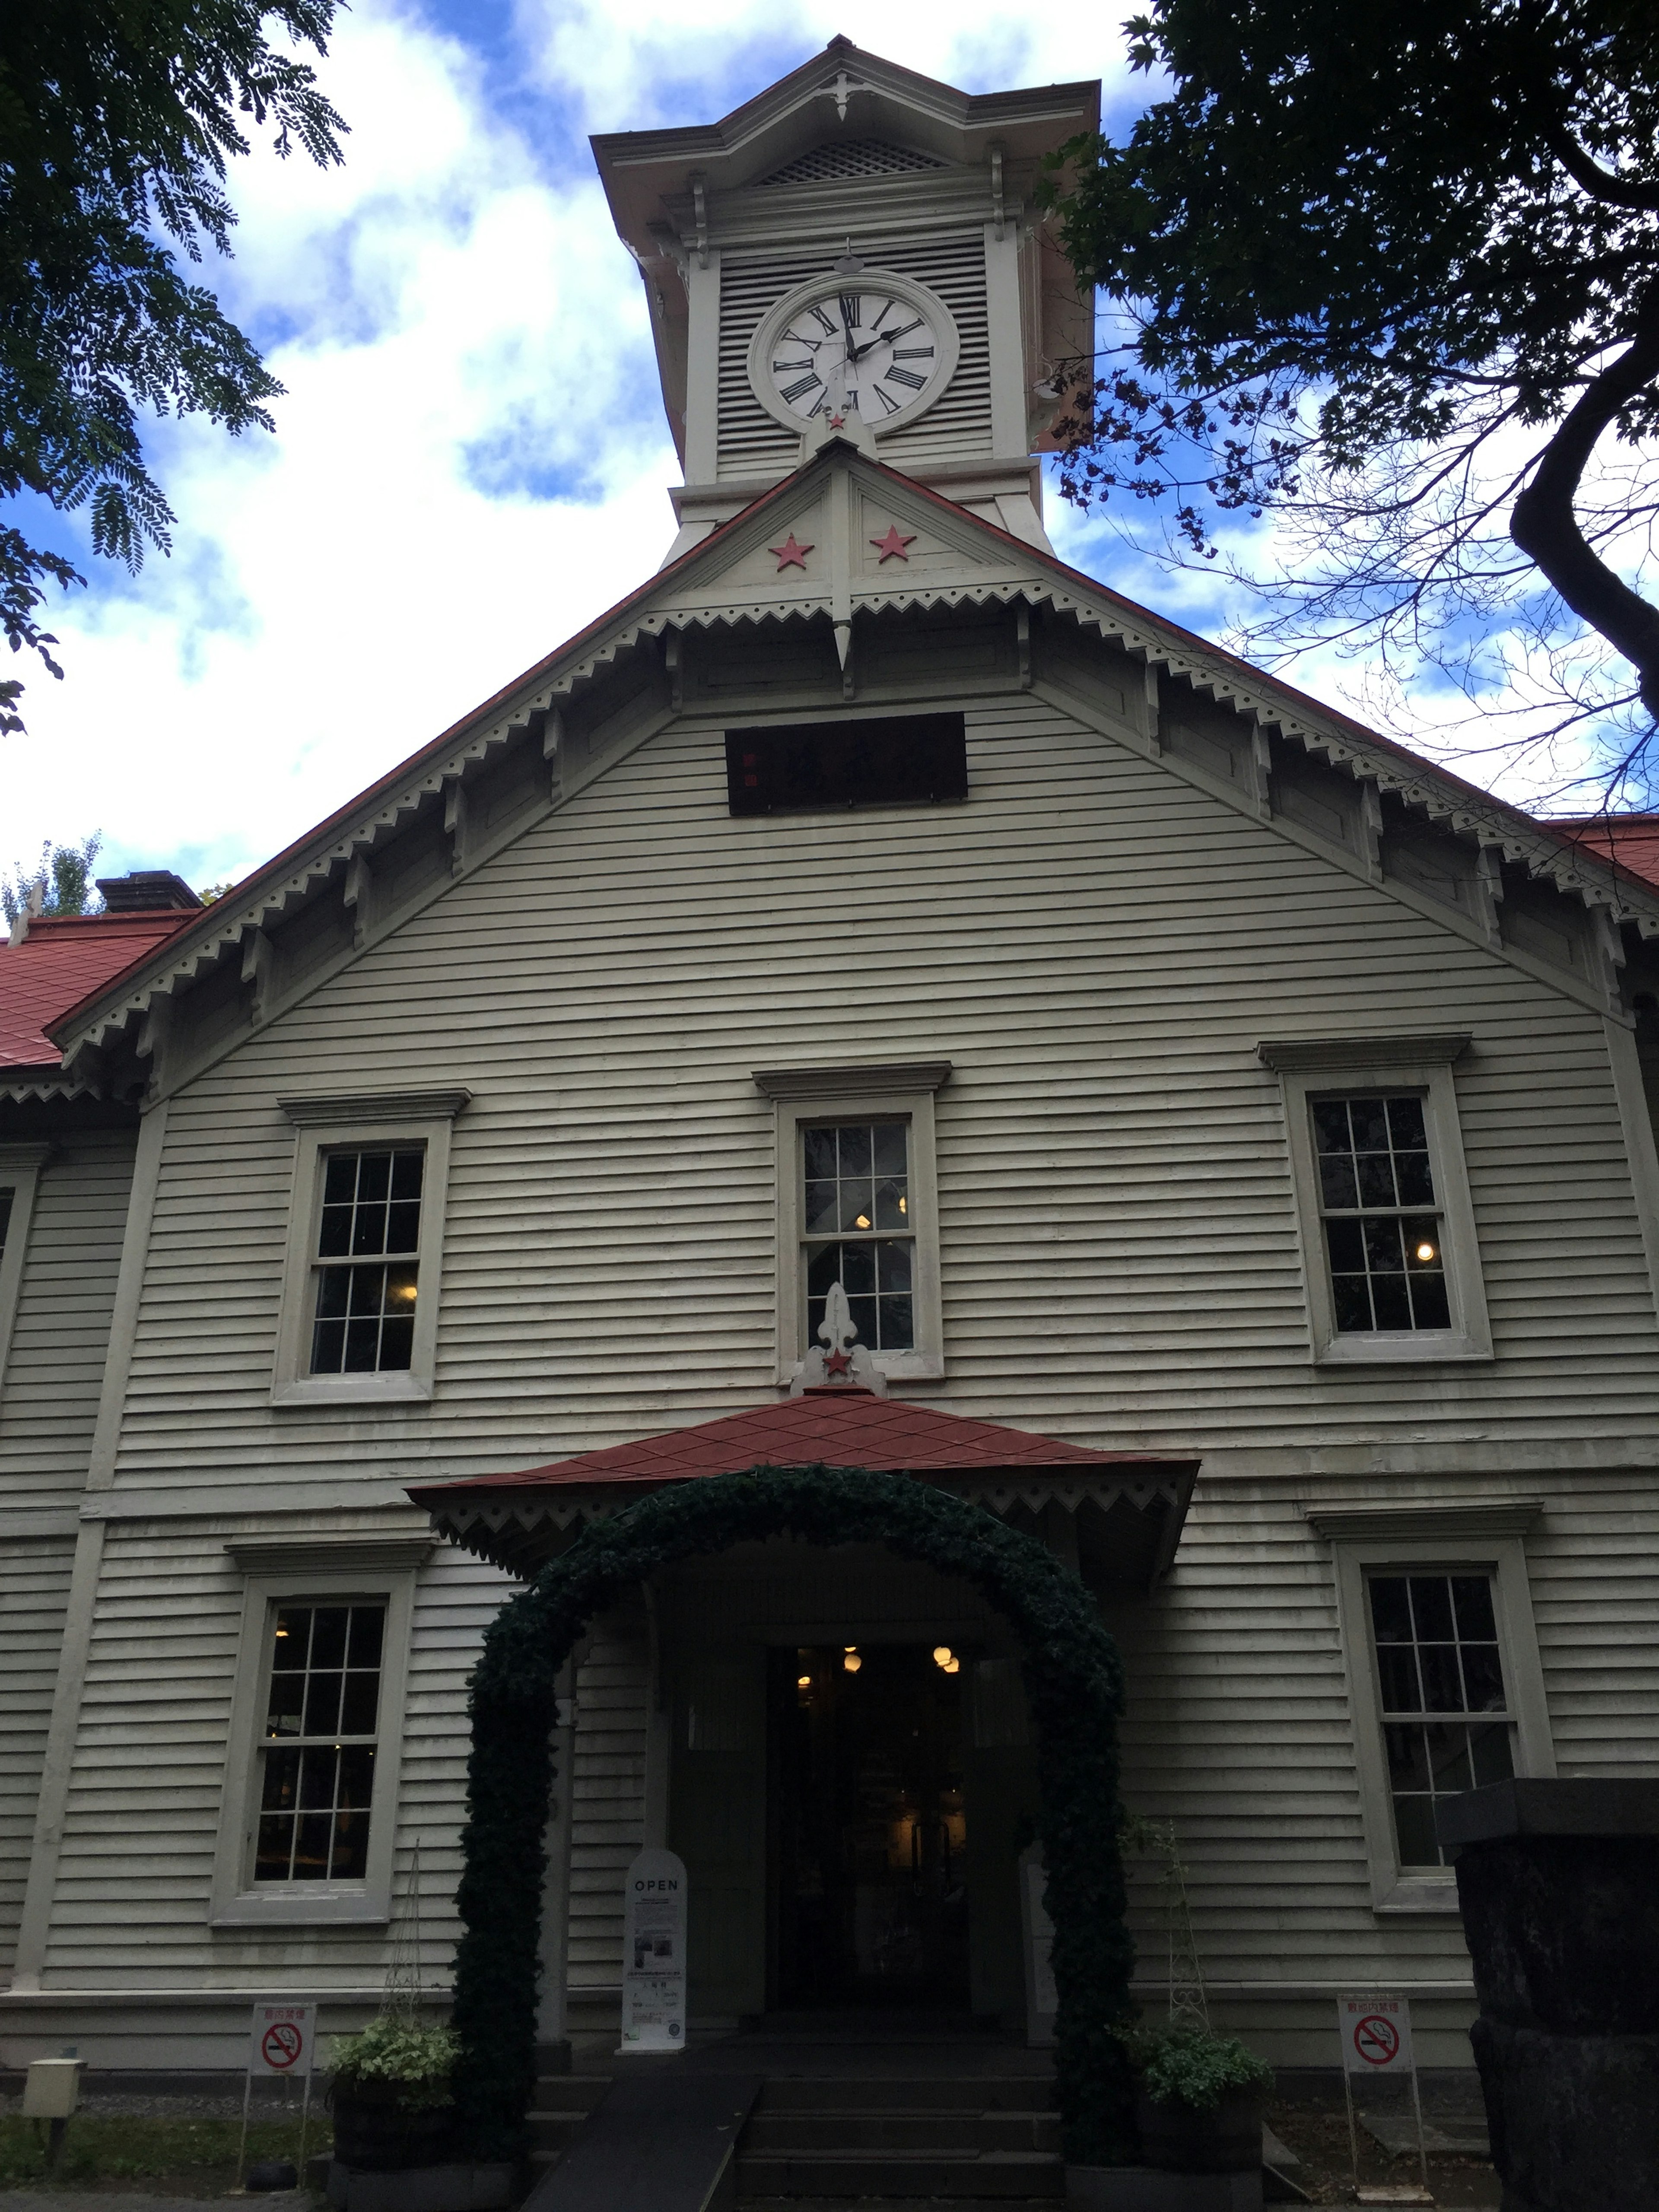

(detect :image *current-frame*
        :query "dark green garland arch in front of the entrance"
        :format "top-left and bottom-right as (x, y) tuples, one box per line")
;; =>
(454, 1467), (1137, 2165)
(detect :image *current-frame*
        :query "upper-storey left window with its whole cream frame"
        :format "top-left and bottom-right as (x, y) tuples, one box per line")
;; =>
(272, 1090), (471, 1405)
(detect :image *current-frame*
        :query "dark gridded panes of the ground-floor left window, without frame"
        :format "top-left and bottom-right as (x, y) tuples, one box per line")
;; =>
(254, 1606), (385, 1882)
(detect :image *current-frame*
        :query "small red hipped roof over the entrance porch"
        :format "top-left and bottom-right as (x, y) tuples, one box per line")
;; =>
(409, 1385), (1197, 1506)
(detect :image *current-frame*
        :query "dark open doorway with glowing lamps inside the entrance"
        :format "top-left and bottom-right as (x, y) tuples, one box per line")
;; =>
(768, 1643), (969, 2009)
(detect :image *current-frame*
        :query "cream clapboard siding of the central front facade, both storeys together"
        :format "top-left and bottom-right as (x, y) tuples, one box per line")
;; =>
(22, 646), (1659, 2011)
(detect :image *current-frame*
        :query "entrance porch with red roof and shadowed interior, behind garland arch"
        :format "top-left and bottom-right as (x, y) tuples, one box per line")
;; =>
(411, 1385), (1197, 2068)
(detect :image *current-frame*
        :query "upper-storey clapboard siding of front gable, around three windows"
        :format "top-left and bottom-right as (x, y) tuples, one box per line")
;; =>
(111, 699), (1659, 1484)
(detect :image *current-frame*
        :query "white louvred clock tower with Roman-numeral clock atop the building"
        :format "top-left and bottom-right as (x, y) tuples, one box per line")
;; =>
(593, 38), (1100, 557)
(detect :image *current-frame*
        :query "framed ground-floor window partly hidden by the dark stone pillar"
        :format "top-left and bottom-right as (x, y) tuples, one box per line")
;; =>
(1303, 1500), (1555, 1913)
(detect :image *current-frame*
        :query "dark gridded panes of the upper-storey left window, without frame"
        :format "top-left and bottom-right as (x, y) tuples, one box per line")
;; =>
(312, 1146), (425, 1376)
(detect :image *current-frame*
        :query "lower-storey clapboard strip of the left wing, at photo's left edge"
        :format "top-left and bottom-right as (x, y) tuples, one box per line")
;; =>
(0, 1537), (75, 1975)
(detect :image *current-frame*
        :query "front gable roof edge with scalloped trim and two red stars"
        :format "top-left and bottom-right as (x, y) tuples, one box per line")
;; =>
(29, 436), (1659, 1088)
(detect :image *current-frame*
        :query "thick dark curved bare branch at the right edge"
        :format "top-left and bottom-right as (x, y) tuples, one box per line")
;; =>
(1509, 283), (1659, 719)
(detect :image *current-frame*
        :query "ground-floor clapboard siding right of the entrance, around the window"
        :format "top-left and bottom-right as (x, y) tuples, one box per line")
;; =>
(1108, 1471), (1659, 1984)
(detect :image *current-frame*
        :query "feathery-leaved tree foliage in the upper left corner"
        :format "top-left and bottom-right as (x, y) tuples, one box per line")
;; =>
(0, 0), (345, 730)
